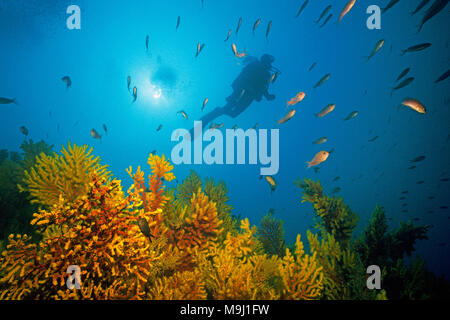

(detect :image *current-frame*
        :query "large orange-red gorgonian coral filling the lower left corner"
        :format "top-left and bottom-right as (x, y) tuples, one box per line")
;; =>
(0, 176), (172, 299)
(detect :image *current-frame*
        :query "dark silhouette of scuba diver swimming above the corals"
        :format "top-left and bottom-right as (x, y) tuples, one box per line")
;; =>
(190, 54), (279, 137)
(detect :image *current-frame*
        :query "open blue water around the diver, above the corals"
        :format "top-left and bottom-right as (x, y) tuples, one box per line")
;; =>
(0, 0), (450, 278)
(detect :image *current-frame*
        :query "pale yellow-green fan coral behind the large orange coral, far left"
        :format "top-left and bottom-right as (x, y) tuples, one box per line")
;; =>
(19, 142), (111, 206)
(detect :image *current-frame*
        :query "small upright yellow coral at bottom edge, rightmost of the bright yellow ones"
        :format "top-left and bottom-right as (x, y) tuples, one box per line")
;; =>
(280, 235), (323, 300)
